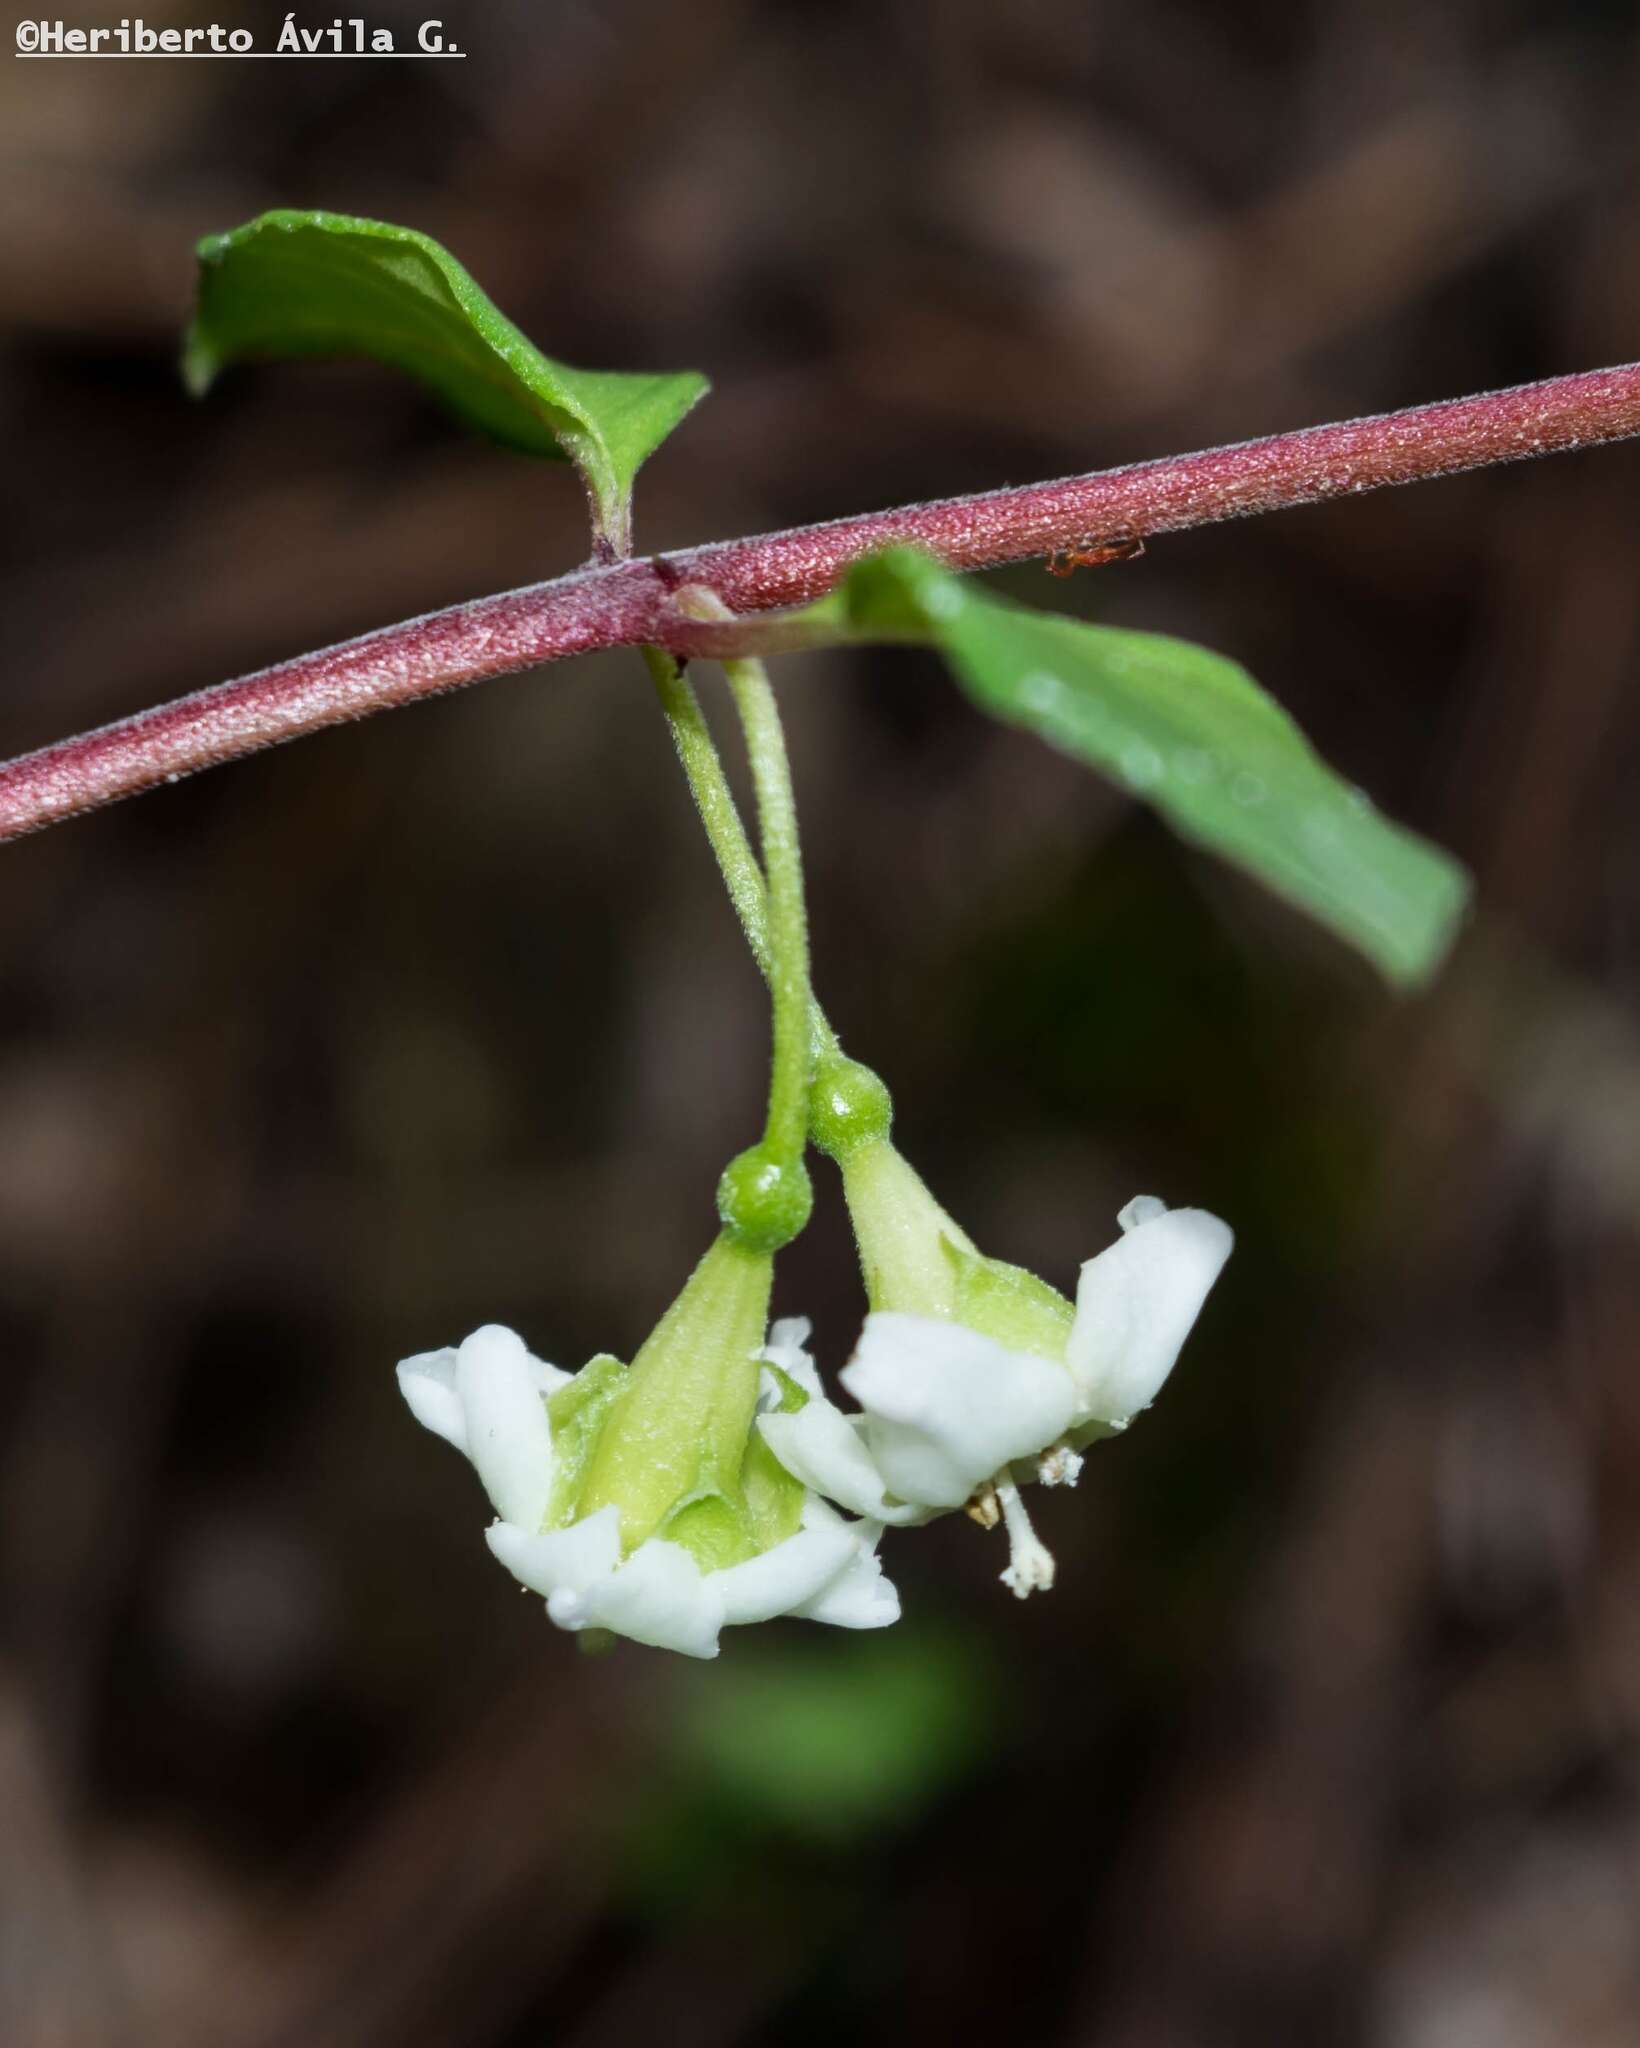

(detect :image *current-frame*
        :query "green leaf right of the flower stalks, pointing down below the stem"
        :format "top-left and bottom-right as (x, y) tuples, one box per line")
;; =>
(829, 549), (1470, 987)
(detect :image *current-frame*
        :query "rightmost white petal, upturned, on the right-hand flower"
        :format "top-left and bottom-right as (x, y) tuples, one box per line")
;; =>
(1065, 1204), (1235, 1423)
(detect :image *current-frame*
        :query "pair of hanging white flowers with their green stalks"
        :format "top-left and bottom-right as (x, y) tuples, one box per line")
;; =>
(399, 647), (1231, 1657)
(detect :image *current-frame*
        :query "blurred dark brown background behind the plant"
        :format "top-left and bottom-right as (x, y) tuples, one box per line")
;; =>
(0, 0), (1640, 2048)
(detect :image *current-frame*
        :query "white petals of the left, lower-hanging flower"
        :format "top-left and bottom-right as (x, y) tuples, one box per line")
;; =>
(399, 1323), (899, 1657)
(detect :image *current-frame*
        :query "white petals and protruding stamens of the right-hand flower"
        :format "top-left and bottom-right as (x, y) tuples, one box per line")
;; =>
(758, 1196), (1233, 1595)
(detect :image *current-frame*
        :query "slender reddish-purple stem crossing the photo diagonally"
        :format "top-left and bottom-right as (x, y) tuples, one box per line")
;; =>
(0, 362), (1640, 840)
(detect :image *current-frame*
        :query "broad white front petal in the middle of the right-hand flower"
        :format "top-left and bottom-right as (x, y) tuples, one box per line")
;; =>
(839, 1311), (1075, 1507)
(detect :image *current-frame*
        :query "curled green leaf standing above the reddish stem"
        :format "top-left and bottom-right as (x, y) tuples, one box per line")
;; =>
(182, 211), (706, 555)
